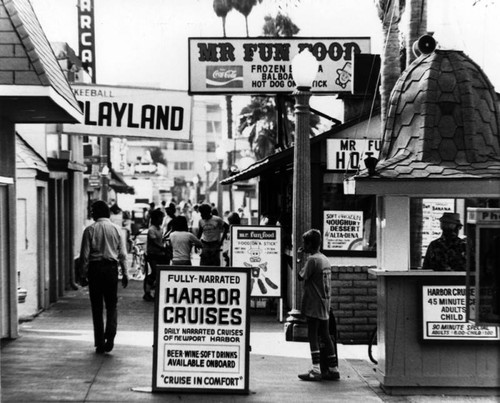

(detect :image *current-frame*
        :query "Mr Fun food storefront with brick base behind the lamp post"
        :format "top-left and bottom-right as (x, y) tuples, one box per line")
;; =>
(222, 115), (380, 343)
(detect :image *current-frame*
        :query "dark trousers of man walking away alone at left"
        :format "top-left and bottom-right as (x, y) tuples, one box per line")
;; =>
(88, 261), (118, 347)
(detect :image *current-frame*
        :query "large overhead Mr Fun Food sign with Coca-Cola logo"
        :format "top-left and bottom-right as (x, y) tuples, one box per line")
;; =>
(189, 38), (370, 94)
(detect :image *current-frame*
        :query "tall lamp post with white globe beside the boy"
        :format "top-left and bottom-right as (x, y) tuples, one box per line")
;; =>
(291, 49), (318, 315)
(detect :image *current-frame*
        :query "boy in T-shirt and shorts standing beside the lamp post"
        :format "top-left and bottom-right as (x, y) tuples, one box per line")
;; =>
(298, 229), (340, 381)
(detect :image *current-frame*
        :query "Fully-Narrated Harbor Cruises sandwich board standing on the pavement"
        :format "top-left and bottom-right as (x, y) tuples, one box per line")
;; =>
(152, 265), (250, 394)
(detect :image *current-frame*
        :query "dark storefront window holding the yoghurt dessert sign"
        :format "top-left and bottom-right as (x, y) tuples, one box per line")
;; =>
(323, 182), (377, 257)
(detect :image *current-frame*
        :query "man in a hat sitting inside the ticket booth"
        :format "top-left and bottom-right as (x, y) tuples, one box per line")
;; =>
(422, 213), (466, 271)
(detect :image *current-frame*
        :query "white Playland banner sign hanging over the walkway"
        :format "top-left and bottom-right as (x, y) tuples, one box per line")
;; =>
(63, 85), (191, 141)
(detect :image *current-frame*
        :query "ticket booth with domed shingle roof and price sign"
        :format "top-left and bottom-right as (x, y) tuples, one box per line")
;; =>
(344, 50), (500, 395)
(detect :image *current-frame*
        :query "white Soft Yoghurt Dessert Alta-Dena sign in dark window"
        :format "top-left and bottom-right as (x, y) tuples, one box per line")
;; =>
(323, 210), (363, 250)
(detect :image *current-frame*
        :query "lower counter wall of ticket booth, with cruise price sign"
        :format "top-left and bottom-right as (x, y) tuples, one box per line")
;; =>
(369, 269), (500, 394)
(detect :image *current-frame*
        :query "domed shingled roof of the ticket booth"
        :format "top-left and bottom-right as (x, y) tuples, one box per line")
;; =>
(346, 50), (500, 196)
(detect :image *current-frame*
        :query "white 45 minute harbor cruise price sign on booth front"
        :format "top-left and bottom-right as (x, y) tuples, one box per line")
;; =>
(422, 286), (500, 340)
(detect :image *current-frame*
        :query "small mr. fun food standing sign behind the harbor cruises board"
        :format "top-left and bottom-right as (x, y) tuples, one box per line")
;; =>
(231, 225), (281, 297)
